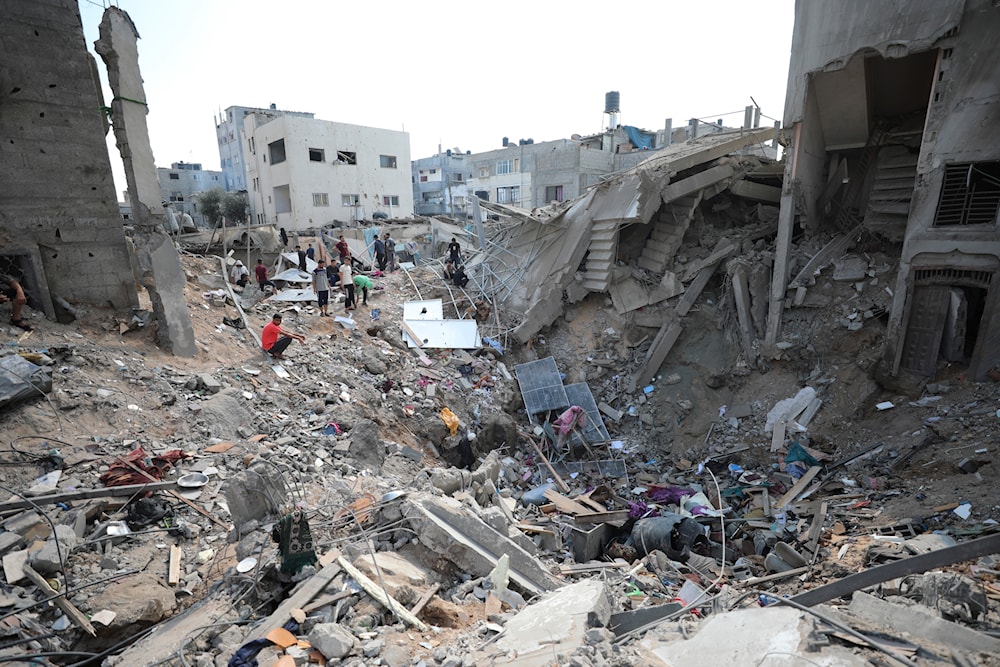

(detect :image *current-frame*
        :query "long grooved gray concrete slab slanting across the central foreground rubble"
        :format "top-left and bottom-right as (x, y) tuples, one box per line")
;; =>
(403, 495), (562, 595)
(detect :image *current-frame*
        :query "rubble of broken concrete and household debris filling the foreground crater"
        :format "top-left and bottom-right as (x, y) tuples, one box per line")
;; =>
(0, 239), (1000, 667)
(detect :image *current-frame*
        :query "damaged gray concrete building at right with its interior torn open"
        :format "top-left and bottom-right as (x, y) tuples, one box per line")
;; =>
(780, 0), (1000, 379)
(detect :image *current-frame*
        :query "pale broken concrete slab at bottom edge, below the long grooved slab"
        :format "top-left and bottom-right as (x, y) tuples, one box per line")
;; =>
(476, 579), (611, 667)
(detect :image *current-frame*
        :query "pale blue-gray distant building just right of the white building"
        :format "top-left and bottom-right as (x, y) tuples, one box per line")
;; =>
(411, 148), (472, 218)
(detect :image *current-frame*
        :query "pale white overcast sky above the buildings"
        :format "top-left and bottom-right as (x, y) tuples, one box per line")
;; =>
(79, 0), (794, 196)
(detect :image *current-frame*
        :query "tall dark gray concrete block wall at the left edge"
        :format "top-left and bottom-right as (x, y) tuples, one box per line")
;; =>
(0, 0), (138, 317)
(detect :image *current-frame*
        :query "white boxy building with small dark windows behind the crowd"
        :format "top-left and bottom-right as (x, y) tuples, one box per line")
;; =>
(244, 113), (413, 231)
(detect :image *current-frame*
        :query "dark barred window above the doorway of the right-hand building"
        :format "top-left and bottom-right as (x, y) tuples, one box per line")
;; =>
(934, 162), (1000, 227)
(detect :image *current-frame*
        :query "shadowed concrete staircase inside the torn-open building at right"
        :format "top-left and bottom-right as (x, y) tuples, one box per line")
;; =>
(865, 146), (917, 242)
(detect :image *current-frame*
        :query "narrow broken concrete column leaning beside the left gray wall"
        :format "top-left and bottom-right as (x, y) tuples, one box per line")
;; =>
(94, 7), (198, 357)
